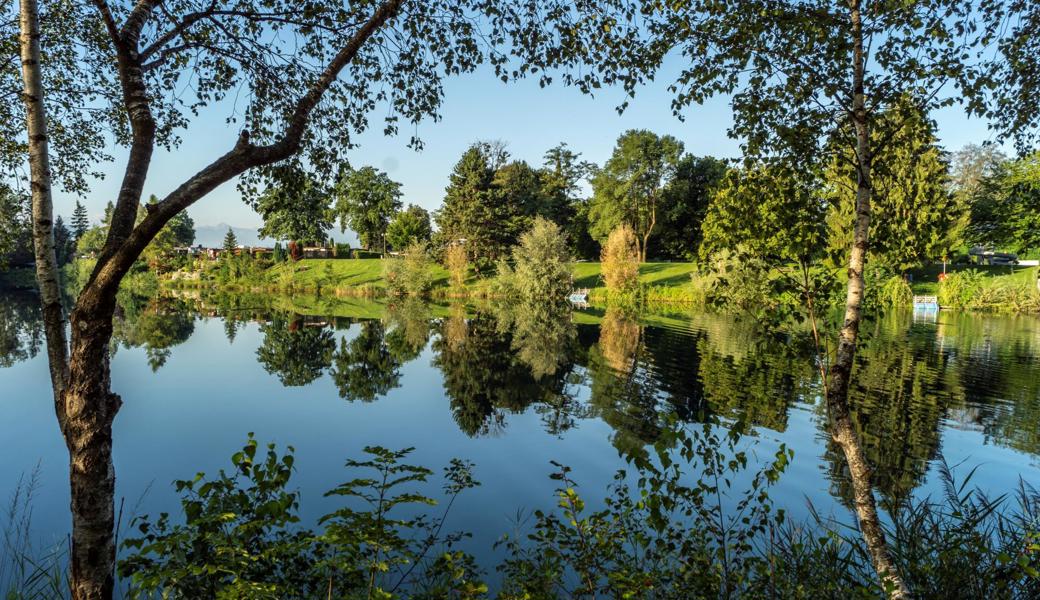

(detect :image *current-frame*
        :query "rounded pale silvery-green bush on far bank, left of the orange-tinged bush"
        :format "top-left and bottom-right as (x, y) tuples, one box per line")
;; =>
(499, 216), (573, 302)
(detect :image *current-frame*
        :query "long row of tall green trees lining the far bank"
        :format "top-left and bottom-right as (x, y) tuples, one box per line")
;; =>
(247, 116), (1040, 287)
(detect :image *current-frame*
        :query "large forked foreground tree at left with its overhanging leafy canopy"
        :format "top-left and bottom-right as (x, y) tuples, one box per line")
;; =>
(12, 0), (543, 599)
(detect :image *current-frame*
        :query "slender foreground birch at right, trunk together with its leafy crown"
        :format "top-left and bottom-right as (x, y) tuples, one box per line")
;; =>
(520, 0), (1006, 597)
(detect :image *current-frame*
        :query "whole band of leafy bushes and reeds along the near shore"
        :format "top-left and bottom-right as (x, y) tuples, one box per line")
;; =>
(119, 428), (1040, 600)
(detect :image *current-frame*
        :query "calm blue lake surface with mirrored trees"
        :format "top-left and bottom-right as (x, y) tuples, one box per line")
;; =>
(0, 287), (1040, 565)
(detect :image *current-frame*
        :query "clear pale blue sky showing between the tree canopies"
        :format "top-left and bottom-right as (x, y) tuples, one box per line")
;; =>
(55, 60), (1006, 227)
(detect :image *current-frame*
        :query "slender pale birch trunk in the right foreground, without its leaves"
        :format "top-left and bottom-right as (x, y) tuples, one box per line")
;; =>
(826, 0), (910, 598)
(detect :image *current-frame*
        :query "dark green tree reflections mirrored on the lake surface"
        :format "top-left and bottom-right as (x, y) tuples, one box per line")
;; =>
(6, 287), (1040, 499)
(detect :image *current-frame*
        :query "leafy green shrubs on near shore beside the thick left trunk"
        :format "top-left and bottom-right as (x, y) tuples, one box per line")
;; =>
(119, 435), (487, 599)
